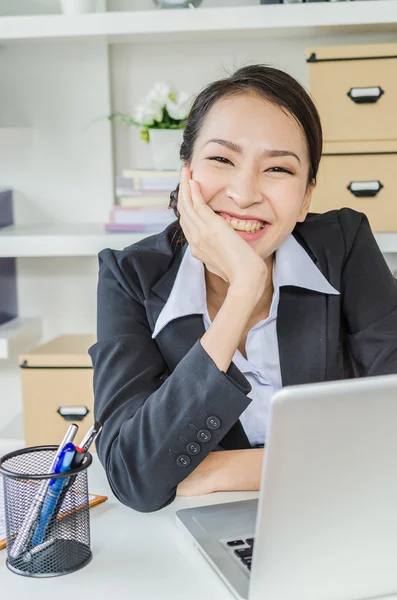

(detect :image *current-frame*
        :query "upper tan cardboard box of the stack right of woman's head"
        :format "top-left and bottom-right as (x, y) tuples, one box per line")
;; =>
(306, 44), (397, 142)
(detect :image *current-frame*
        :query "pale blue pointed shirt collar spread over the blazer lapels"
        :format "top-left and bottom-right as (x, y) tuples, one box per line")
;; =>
(152, 234), (339, 338)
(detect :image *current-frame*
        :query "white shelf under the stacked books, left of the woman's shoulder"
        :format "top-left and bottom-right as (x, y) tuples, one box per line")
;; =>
(0, 223), (156, 257)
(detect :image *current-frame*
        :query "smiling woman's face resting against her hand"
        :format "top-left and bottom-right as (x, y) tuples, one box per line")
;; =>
(189, 95), (313, 258)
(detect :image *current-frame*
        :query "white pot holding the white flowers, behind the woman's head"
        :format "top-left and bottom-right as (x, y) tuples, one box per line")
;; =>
(149, 129), (183, 171)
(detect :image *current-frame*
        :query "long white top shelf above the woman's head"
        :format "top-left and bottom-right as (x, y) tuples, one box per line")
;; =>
(0, 0), (397, 43)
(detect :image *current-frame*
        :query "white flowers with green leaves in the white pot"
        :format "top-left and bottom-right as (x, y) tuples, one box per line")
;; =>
(109, 81), (193, 143)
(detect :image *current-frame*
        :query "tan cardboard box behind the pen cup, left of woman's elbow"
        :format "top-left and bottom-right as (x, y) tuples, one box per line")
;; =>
(19, 334), (96, 450)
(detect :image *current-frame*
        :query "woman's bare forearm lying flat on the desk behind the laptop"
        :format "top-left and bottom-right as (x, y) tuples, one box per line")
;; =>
(177, 448), (263, 496)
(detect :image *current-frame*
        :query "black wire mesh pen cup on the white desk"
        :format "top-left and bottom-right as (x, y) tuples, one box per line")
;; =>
(0, 446), (92, 577)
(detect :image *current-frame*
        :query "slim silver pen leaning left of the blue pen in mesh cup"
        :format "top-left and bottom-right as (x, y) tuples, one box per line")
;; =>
(9, 423), (78, 559)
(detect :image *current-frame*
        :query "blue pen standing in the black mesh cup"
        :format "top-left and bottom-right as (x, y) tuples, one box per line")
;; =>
(32, 443), (76, 547)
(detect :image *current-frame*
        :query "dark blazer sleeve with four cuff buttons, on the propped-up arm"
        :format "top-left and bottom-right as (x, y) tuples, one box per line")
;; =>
(89, 249), (251, 512)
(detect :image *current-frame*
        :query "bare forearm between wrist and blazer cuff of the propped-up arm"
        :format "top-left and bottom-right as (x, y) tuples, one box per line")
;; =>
(200, 287), (255, 372)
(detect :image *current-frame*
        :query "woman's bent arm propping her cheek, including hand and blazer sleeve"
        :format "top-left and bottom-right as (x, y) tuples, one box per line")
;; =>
(89, 166), (267, 511)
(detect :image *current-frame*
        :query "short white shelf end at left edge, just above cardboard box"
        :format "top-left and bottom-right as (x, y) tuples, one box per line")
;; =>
(0, 317), (42, 360)
